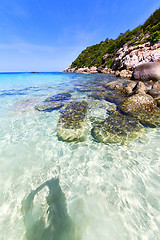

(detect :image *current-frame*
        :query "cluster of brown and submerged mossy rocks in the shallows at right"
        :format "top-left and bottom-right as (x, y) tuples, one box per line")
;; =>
(57, 72), (160, 144)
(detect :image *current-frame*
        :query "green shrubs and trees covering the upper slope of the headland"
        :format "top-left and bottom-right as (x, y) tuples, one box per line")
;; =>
(71, 8), (160, 69)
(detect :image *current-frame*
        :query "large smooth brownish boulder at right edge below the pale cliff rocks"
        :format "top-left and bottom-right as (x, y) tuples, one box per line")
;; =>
(132, 62), (160, 81)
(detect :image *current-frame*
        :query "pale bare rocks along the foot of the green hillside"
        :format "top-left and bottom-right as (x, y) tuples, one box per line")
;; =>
(64, 42), (160, 78)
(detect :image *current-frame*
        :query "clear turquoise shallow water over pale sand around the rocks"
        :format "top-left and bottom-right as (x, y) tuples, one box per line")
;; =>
(0, 73), (160, 240)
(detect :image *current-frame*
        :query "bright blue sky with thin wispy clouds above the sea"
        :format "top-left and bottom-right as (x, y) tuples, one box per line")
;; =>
(0, 0), (160, 72)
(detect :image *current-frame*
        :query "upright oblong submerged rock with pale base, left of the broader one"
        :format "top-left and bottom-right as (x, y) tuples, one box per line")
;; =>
(57, 101), (88, 141)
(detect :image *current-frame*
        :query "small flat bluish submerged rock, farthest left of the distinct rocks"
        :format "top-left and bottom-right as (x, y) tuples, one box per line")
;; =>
(35, 102), (64, 111)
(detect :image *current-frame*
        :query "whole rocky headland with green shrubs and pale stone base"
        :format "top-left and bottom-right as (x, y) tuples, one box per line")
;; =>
(65, 8), (160, 77)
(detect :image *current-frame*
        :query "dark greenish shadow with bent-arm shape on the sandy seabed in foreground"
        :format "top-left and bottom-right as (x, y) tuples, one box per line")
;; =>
(22, 178), (75, 240)
